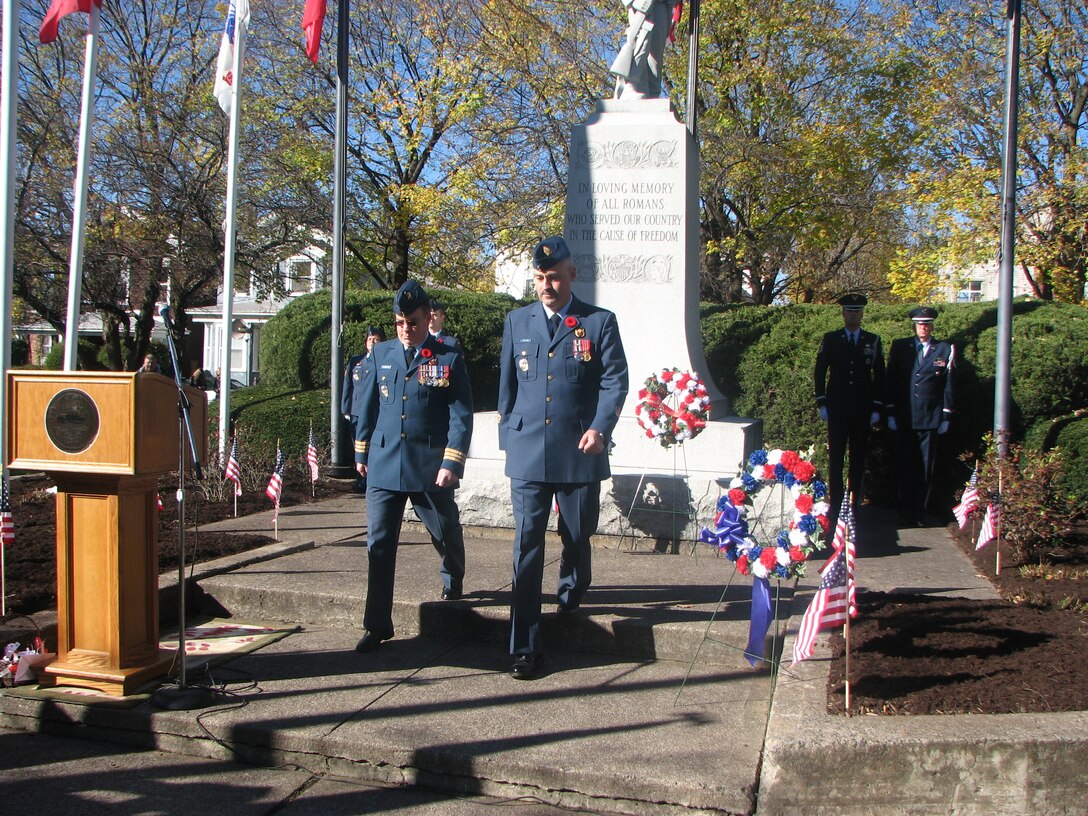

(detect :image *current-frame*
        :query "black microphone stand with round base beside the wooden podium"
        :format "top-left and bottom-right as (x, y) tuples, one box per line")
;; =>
(151, 306), (215, 710)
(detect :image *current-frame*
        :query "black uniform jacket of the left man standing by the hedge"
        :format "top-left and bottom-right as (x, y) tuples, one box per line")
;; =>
(813, 329), (885, 417)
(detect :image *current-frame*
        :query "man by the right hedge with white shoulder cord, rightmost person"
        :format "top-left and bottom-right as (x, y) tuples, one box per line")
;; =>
(885, 306), (955, 527)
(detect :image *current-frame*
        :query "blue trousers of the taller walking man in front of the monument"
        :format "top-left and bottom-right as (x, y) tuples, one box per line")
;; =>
(510, 479), (601, 655)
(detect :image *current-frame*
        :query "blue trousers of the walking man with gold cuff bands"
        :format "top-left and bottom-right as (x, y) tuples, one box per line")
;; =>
(362, 485), (465, 635)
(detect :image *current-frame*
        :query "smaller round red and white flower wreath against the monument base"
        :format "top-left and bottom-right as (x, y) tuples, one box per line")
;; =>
(634, 368), (710, 447)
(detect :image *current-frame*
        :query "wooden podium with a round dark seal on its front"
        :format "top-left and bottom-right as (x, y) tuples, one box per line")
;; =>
(5, 371), (208, 695)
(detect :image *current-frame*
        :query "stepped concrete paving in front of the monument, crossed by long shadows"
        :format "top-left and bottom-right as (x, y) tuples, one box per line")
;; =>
(0, 495), (1088, 814)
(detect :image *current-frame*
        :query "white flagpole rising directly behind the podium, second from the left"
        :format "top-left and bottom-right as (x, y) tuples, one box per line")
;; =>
(61, 3), (101, 371)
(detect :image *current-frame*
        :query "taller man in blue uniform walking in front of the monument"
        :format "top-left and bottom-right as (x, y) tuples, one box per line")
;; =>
(498, 237), (628, 680)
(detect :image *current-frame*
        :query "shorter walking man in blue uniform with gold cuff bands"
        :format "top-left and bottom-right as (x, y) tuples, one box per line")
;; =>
(355, 281), (472, 652)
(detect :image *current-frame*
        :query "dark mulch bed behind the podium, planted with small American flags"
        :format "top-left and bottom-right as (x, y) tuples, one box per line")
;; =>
(0, 477), (351, 617)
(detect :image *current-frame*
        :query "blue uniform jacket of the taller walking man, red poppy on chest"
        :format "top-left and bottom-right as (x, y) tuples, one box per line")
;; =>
(498, 298), (628, 483)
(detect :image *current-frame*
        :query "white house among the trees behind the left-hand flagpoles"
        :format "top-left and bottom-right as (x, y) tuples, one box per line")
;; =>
(189, 247), (329, 385)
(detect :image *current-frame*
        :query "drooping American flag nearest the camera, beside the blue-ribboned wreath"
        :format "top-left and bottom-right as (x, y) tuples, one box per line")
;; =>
(793, 497), (857, 664)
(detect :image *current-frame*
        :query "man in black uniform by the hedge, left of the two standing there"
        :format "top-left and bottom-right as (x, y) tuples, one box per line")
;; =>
(813, 295), (885, 520)
